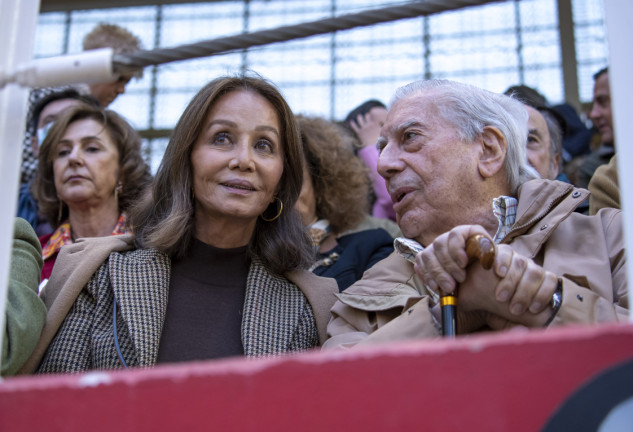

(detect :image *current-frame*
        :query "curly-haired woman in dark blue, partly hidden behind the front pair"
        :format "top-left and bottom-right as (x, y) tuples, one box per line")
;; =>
(296, 115), (399, 291)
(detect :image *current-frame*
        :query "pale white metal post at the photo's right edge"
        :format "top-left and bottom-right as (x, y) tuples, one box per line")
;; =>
(604, 0), (633, 322)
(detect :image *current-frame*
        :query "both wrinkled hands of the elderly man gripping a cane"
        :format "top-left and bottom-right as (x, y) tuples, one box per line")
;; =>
(415, 225), (558, 326)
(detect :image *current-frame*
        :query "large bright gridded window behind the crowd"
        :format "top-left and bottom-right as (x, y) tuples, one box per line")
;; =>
(35, 0), (608, 171)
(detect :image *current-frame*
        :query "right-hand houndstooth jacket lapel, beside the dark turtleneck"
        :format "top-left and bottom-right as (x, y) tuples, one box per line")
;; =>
(242, 259), (306, 357)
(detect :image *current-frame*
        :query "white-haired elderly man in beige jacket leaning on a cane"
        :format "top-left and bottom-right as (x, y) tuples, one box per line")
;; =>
(326, 81), (628, 347)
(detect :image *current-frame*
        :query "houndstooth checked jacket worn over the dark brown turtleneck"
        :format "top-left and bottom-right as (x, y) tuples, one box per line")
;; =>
(38, 235), (337, 373)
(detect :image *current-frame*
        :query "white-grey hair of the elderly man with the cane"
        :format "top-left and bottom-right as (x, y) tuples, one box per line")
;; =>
(389, 80), (540, 194)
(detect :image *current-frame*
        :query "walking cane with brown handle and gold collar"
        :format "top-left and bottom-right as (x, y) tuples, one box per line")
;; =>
(440, 234), (495, 338)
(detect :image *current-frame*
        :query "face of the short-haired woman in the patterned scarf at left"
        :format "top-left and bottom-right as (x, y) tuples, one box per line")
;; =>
(53, 119), (119, 209)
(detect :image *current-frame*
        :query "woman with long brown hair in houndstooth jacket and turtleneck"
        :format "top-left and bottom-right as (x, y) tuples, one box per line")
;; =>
(29, 77), (336, 372)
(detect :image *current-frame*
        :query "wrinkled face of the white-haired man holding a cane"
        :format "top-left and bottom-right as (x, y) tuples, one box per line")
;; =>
(378, 92), (480, 245)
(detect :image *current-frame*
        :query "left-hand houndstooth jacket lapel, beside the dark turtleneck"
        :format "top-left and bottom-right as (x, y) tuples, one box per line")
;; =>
(109, 249), (171, 366)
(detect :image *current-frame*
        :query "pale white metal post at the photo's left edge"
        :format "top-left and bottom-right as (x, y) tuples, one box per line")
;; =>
(0, 0), (40, 372)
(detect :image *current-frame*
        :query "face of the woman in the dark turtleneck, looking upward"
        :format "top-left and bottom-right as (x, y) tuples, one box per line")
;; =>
(191, 90), (284, 229)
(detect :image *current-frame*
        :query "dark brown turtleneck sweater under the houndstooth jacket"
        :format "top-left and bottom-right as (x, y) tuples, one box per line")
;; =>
(157, 239), (250, 363)
